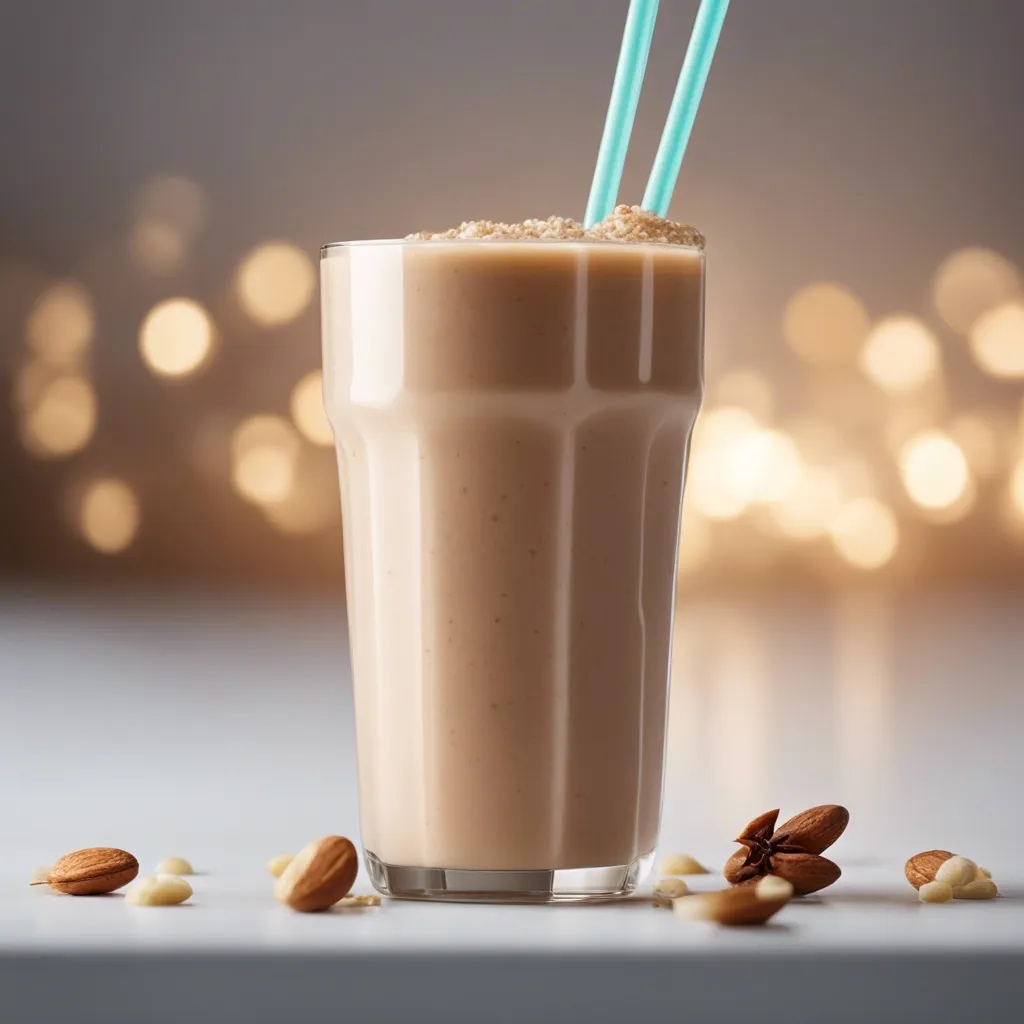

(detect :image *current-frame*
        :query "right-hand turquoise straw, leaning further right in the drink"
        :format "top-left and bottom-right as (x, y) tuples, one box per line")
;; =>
(641, 0), (729, 217)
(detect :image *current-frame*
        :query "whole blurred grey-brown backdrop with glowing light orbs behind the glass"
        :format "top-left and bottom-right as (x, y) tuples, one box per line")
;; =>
(0, 0), (1024, 592)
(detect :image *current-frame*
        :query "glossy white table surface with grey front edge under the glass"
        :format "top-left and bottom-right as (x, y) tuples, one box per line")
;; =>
(0, 591), (1024, 1024)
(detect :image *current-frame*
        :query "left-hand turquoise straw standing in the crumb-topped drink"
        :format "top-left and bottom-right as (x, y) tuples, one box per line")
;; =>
(584, 0), (658, 227)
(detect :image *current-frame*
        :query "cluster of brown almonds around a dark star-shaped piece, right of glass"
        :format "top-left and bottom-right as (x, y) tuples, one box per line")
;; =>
(725, 804), (850, 896)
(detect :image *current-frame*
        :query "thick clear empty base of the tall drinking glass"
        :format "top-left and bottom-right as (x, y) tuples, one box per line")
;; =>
(364, 850), (654, 903)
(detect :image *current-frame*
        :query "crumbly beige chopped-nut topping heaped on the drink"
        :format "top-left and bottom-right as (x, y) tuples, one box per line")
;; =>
(409, 206), (705, 250)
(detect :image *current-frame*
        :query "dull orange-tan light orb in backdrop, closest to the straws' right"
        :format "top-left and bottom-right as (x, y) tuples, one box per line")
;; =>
(782, 282), (870, 366)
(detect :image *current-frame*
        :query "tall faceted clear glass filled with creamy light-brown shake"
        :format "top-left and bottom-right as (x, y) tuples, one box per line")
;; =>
(322, 235), (705, 902)
